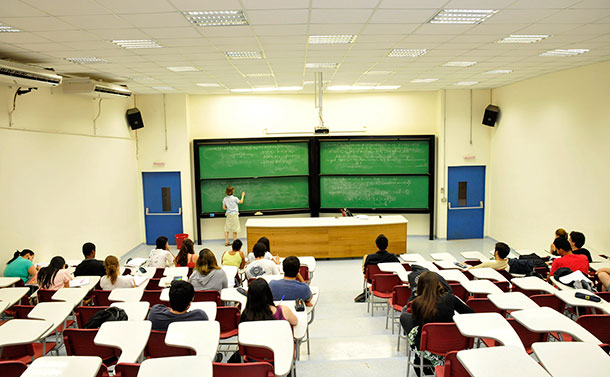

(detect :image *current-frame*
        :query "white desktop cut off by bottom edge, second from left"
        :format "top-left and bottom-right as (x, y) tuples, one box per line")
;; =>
(138, 356), (212, 377)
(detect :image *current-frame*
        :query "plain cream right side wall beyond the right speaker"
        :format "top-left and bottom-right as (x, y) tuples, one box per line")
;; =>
(490, 62), (610, 252)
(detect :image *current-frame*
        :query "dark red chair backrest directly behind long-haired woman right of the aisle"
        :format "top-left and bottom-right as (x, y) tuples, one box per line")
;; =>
(419, 322), (472, 355)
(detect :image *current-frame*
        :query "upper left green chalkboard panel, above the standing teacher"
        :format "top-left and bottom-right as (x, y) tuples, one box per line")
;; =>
(199, 142), (309, 179)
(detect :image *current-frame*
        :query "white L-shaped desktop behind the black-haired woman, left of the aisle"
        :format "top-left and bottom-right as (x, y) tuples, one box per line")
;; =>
(238, 321), (294, 376)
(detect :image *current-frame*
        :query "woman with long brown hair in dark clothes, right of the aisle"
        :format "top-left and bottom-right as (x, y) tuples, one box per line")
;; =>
(400, 271), (473, 376)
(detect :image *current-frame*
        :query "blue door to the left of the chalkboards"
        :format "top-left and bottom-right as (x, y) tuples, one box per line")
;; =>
(142, 172), (182, 245)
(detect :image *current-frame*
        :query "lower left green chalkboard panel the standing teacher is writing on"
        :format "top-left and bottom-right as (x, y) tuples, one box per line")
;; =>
(201, 177), (309, 212)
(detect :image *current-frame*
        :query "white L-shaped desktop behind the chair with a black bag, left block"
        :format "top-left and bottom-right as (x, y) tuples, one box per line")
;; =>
(93, 321), (152, 363)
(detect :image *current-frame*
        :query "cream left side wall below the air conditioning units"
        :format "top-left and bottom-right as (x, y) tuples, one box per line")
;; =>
(0, 86), (141, 265)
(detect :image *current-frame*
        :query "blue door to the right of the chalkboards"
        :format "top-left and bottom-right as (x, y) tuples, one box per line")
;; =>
(447, 166), (485, 240)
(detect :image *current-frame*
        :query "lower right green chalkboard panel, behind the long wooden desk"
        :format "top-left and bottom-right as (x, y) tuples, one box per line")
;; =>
(320, 176), (429, 209)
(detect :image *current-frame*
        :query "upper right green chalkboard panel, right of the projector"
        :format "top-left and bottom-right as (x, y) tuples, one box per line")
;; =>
(320, 140), (430, 174)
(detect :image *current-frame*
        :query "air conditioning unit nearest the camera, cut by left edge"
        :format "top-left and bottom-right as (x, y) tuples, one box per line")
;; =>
(0, 60), (62, 88)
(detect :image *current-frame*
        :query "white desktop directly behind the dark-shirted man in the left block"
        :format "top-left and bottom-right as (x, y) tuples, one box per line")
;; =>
(165, 321), (220, 359)
